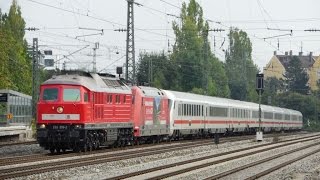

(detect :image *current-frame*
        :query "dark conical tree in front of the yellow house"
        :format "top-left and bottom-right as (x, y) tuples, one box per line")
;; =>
(284, 56), (310, 94)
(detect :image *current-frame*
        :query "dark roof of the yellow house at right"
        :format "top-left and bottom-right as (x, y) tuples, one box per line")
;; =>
(276, 54), (317, 69)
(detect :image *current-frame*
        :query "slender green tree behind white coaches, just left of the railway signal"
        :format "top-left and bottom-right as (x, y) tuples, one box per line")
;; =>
(226, 29), (258, 101)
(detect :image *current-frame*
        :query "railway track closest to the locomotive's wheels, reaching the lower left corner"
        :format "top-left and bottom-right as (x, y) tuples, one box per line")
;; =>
(0, 131), (312, 179)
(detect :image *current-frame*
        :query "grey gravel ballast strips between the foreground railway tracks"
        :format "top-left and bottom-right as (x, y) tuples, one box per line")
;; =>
(5, 134), (320, 180)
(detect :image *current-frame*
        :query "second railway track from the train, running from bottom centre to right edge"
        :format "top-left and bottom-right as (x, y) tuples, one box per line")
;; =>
(105, 136), (320, 179)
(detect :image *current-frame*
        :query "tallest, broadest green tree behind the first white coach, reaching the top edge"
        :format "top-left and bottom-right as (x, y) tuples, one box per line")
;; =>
(170, 0), (229, 97)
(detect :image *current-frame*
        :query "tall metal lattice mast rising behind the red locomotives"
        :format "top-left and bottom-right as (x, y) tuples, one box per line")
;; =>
(125, 0), (136, 84)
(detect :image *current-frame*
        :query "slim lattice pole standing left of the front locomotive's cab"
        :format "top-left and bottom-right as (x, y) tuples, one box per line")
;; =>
(32, 38), (39, 119)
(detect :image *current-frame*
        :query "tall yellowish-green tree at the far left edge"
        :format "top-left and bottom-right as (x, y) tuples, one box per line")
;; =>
(0, 0), (32, 94)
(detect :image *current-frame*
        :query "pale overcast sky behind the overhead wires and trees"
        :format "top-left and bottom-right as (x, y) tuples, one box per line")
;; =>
(0, 0), (320, 73)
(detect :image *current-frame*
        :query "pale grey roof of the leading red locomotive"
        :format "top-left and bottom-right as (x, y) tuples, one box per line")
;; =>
(43, 73), (131, 94)
